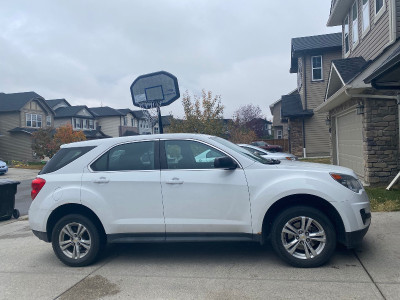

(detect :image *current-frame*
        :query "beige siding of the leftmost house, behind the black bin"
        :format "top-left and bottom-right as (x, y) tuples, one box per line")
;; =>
(0, 112), (35, 161)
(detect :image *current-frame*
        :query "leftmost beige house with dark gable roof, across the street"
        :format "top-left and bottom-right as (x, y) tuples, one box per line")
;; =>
(0, 92), (54, 161)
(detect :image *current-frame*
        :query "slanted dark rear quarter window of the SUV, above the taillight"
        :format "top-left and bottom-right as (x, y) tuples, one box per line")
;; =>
(39, 146), (95, 174)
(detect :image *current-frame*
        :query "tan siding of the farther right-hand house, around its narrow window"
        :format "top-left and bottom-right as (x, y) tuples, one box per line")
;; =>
(303, 50), (341, 157)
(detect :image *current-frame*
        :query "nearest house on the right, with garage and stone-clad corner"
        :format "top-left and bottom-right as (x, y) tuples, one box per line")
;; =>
(316, 0), (400, 184)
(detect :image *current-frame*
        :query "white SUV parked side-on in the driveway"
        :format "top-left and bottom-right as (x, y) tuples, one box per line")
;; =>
(29, 134), (371, 267)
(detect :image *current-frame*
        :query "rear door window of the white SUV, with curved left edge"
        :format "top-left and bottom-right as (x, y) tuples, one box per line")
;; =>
(91, 141), (155, 171)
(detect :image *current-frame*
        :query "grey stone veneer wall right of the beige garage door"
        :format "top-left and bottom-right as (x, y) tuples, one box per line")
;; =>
(364, 98), (399, 184)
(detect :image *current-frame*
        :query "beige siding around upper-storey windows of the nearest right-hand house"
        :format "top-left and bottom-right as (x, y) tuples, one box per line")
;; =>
(342, 0), (390, 60)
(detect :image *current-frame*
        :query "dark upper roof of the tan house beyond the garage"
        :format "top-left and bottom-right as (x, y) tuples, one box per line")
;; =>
(290, 32), (342, 73)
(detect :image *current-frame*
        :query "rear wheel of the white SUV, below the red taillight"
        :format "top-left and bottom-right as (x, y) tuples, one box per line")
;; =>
(51, 214), (102, 267)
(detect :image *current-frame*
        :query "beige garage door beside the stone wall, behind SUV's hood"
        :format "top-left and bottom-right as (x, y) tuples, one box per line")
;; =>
(336, 110), (364, 178)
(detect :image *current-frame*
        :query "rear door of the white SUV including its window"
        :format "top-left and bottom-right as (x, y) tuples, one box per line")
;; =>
(81, 141), (165, 239)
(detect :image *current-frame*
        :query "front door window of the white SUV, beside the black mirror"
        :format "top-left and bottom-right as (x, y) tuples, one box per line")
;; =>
(165, 141), (226, 169)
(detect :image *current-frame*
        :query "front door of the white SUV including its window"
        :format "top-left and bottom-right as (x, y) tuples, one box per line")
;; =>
(160, 140), (252, 240)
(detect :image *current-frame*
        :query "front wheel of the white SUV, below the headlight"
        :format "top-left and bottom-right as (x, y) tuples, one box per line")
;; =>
(271, 206), (336, 268)
